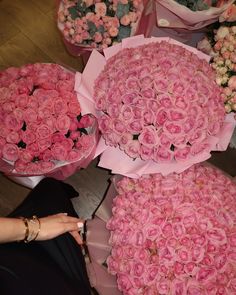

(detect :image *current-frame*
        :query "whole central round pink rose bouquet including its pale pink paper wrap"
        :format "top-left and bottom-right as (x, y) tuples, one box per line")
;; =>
(75, 36), (234, 177)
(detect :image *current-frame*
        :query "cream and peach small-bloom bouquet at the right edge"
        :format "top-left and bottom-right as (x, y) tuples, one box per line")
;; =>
(197, 4), (236, 113)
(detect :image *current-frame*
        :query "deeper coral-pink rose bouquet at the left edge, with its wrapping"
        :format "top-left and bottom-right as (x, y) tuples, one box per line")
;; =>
(0, 63), (97, 177)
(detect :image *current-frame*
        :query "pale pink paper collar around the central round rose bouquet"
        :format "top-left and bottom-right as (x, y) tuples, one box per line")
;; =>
(75, 35), (234, 178)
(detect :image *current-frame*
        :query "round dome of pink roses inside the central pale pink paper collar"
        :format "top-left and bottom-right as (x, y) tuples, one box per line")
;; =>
(94, 41), (225, 163)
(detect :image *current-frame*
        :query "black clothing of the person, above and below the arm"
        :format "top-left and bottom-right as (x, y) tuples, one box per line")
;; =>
(0, 178), (90, 295)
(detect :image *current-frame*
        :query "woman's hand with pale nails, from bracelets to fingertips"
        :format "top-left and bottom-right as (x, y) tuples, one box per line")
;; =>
(36, 213), (84, 245)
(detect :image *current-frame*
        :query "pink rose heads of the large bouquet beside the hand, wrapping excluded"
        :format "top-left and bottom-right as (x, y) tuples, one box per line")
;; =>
(107, 164), (236, 295)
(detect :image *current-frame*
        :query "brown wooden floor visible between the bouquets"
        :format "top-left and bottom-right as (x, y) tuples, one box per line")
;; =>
(0, 0), (236, 218)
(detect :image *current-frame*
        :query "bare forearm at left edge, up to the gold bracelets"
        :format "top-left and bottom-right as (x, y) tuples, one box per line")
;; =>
(0, 217), (25, 243)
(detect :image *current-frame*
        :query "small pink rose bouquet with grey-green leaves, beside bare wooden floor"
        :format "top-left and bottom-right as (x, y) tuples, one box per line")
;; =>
(58, 0), (143, 49)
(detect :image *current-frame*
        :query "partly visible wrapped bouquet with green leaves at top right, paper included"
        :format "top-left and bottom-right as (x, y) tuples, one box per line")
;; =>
(155, 0), (234, 31)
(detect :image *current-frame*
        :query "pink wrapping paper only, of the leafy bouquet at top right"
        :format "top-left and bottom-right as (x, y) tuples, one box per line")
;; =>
(155, 0), (233, 30)
